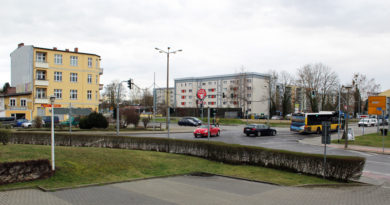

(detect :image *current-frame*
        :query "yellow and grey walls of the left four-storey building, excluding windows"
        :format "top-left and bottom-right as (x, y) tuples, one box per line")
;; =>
(6, 46), (102, 119)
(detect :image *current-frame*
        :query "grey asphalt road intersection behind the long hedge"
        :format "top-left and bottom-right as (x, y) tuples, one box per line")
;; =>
(126, 124), (390, 184)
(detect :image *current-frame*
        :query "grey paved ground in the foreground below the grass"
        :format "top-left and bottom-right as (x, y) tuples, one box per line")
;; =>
(0, 176), (390, 205)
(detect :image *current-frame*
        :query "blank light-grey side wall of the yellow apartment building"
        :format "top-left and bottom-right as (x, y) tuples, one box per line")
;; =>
(11, 46), (33, 92)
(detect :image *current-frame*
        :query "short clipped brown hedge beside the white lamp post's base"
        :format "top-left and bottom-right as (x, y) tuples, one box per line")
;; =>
(0, 159), (53, 185)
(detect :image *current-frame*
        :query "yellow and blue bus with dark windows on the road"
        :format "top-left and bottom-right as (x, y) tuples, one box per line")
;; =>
(290, 111), (340, 134)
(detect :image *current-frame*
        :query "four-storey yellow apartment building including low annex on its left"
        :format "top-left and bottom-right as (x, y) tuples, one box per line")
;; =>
(4, 43), (103, 120)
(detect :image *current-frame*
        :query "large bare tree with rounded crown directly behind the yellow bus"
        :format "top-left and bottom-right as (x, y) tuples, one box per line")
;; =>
(297, 63), (339, 112)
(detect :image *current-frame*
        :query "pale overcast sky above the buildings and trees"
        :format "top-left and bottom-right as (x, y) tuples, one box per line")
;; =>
(0, 0), (390, 90)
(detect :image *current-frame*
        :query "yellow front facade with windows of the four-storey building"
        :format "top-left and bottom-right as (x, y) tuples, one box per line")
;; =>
(5, 47), (103, 119)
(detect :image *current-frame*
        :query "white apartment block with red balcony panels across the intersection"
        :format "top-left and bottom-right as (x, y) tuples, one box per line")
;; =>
(174, 72), (270, 115)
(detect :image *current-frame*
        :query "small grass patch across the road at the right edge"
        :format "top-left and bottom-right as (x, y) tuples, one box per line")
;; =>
(332, 133), (390, 148)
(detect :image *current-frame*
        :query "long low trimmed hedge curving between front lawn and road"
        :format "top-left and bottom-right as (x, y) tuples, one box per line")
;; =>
(6, 133), (365, 181)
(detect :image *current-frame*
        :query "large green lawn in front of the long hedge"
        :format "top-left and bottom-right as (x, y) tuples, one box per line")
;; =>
(0, 144), (338, 190)
